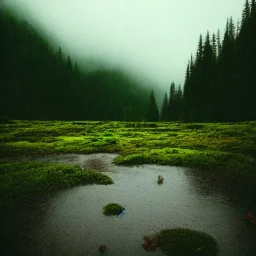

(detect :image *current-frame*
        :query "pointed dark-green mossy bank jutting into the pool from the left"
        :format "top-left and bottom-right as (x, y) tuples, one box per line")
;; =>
(0, 161), (113, 204)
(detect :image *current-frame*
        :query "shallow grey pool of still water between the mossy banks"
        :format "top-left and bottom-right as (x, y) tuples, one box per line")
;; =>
(2, 154), (256, 256)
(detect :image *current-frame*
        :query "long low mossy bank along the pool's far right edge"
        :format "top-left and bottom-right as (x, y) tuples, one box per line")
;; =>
(114, 148), (256, 178)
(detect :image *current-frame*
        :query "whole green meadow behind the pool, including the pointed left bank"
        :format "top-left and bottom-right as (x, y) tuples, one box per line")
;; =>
(0, 120), (256, 202)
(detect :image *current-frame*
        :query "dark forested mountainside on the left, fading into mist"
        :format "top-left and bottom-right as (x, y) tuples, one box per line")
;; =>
(0, 9), (149, 121)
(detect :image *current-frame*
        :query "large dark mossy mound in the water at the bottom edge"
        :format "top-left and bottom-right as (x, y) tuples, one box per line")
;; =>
(143, 228), (218, 256)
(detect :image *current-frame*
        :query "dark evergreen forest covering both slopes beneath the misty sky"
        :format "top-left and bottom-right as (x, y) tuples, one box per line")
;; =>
(0, 0), (256, 122)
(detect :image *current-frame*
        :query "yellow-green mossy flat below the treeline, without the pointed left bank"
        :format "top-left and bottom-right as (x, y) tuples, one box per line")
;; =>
(0, 121), (256, 202)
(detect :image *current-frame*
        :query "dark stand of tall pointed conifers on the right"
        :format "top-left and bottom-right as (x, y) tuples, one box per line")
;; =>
(161, 0), (256, 122)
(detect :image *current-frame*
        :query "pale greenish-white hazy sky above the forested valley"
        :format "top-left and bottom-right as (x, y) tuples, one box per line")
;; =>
(4, 0), (245, 88)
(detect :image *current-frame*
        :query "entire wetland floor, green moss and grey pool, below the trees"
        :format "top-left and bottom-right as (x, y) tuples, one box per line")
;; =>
(0, 120), (256, 256)
